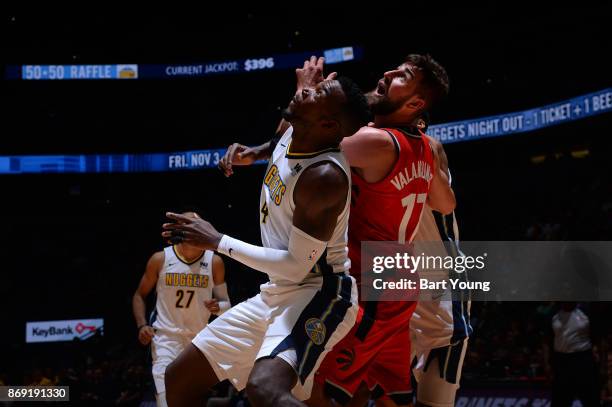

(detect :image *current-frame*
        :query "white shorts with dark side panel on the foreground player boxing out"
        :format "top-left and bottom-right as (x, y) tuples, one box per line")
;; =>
(192, 274), (358, 400)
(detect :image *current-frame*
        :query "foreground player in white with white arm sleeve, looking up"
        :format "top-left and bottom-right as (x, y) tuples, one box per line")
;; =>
(162, 79), (369, 407)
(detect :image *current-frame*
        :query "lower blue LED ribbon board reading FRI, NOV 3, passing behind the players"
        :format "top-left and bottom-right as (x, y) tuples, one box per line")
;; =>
(0, 88), (612, 174)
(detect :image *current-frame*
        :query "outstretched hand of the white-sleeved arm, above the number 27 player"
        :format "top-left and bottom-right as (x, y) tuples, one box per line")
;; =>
(162, 212), (223, 250)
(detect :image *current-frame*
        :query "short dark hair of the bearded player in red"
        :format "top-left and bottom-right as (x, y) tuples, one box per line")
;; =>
(404, 54), (449, 108)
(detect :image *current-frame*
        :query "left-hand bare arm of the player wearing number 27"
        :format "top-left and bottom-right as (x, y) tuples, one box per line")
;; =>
(132, 251), (164, 345)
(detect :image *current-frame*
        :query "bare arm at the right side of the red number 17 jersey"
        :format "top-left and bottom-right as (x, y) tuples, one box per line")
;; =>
(427, 136), (457, 215)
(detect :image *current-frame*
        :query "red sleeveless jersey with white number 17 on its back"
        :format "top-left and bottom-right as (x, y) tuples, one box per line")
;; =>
(348, 129), (434, 318)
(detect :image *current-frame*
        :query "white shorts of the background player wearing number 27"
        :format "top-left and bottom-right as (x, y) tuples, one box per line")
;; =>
(151, 331), (191, 394)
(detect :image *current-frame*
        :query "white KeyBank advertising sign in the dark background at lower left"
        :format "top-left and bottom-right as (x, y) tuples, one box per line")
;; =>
(26, 319), (104, 343)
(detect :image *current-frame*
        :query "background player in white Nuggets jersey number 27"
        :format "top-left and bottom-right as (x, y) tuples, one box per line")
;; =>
(132, 212), (230, 406)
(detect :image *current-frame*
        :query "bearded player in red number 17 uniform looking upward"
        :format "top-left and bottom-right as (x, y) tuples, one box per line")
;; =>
(220, 55), (455, 406)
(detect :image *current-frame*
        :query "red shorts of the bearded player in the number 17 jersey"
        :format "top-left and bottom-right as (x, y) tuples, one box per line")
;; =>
(315, 303), (416, 405)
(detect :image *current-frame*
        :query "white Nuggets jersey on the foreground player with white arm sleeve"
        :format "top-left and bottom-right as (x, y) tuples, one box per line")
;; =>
(260, 127), (350, 291)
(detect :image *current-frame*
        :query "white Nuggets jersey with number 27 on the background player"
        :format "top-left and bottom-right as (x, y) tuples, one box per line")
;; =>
(152, 246), (214, 339)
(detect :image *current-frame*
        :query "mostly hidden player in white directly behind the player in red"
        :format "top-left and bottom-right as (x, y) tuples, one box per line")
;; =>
(410, 117), (472, 407)
